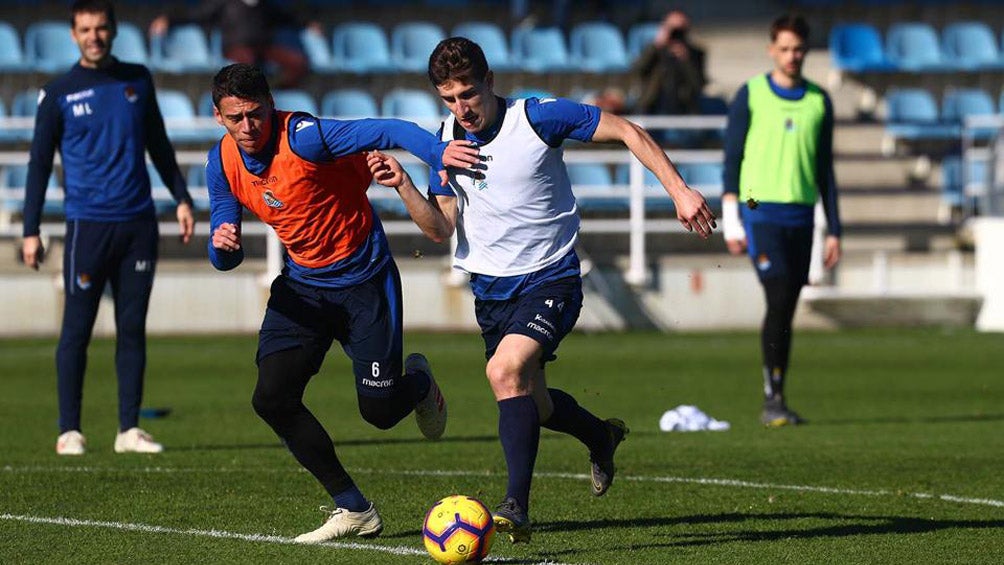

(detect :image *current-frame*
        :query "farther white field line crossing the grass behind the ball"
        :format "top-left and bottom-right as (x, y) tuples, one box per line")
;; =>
(7, 466), (1004, 509)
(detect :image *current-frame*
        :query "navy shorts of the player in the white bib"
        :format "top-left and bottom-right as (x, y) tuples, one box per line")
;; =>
(474, 277), (582, 363)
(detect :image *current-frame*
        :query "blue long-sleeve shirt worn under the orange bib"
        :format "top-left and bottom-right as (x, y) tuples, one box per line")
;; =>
(206, 113), (447, 287)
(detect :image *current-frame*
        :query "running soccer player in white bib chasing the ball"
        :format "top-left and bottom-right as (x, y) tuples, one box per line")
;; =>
(369, 37), (715, 542)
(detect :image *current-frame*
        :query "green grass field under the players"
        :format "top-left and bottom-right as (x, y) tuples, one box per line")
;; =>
(0, 330), (1004, 564)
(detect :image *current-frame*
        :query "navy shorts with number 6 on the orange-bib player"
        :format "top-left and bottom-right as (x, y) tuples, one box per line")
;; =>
(257, 261), (403, 397)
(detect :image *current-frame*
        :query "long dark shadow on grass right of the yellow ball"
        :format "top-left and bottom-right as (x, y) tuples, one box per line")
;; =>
(534, 513), (1004, 550)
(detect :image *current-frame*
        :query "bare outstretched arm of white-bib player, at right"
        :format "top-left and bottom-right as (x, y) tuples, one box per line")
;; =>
(592, 111), (717, 238)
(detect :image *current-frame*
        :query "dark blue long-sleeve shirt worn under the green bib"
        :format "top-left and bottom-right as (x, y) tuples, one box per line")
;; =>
(722, 74), (842, 237)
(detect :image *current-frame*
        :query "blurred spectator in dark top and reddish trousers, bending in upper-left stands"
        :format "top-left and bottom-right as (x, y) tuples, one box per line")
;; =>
(150, 0), (321, 88)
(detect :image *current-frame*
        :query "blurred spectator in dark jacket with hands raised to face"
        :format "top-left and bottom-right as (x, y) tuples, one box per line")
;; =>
(632, 10), (707, 114)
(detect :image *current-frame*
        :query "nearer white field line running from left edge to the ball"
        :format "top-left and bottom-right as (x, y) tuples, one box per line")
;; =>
(0, 514), (566, 565)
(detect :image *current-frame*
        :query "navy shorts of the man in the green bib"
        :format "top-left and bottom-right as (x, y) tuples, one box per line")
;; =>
(746, 222), (812, 284)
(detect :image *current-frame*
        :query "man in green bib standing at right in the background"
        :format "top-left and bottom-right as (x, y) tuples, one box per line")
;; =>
(722, 16), (840, 427)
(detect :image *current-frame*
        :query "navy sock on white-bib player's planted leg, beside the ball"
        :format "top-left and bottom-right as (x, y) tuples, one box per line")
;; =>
(498, 396), (540, 510)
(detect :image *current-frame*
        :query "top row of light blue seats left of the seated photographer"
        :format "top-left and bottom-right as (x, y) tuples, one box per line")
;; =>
(0, 20), (659, 73)
